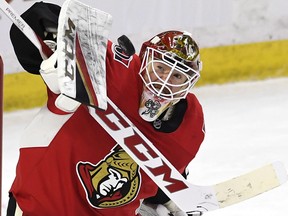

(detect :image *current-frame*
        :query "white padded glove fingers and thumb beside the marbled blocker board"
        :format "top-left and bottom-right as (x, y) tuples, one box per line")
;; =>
(39, 52), (80, 113)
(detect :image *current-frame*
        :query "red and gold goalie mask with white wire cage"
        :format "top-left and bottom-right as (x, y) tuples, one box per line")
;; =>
(139, 31), (201, 121)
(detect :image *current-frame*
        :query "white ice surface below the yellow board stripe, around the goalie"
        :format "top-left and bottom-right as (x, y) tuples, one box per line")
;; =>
(2, 78), (288, 216)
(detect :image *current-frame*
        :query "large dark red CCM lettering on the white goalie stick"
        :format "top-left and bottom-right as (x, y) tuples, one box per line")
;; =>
(90, 106), (188, 193)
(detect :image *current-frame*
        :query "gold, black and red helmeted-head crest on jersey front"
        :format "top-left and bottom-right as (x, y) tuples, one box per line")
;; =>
(77, 146), (141, 208)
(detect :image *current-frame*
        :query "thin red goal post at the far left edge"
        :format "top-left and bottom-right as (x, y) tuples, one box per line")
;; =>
(0, 56), (4, 216)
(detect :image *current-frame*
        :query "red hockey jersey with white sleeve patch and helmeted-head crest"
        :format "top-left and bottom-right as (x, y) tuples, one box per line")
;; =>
(11, 42), (204, 216)
